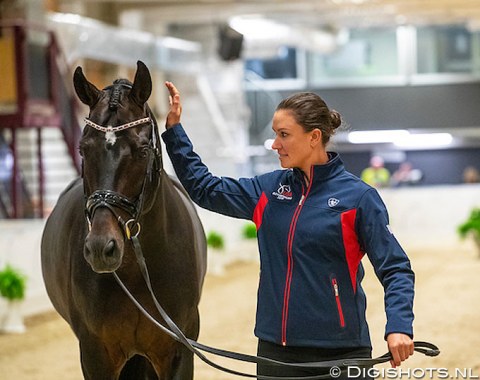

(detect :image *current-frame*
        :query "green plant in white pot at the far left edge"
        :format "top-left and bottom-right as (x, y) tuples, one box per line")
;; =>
(0, 265), (27, 333)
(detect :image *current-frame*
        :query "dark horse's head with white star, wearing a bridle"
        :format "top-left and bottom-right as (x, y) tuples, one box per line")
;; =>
(73, 61), (161, 273)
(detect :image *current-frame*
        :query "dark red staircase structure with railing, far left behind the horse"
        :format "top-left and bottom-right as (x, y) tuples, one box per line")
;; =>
(0, 22), (81, 219)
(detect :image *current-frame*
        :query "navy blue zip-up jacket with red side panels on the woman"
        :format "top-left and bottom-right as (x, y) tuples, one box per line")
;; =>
(162, 124), (414, 348)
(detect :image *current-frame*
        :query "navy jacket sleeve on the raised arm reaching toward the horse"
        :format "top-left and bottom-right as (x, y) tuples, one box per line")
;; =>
(162, 124), (261, 220)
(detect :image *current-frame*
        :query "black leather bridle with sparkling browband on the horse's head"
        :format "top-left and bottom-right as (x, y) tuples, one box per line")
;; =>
(84, 116), (162, 240)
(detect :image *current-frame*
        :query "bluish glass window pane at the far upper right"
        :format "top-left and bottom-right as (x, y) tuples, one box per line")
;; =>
(417, 26), (473, 74)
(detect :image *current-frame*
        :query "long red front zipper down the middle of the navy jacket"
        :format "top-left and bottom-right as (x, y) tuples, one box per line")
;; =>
(282, 167), (313, 346)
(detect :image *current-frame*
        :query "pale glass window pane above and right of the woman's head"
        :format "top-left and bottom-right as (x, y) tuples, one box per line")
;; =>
(310, 28), (399, 81)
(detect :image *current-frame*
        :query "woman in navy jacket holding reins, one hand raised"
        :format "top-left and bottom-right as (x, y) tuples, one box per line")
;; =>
(162, 82), (414, 376)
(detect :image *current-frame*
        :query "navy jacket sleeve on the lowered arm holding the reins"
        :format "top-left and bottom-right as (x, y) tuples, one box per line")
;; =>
(357, 188), (415, 338)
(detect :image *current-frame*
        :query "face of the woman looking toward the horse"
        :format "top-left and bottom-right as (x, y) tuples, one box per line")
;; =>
(272, 110), (313, 173)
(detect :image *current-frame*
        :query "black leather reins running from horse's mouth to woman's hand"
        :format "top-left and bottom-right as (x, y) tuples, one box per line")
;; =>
(113, 236), (440, 380)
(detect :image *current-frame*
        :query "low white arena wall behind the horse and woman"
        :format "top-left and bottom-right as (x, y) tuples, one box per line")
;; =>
(0, 185), (480, 315)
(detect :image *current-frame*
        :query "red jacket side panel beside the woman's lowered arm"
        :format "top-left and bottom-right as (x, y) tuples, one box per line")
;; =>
(341, 209), (365, 293)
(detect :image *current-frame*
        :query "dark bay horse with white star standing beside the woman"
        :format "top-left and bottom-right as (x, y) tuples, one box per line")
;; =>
(41, 62), (206, 380)
